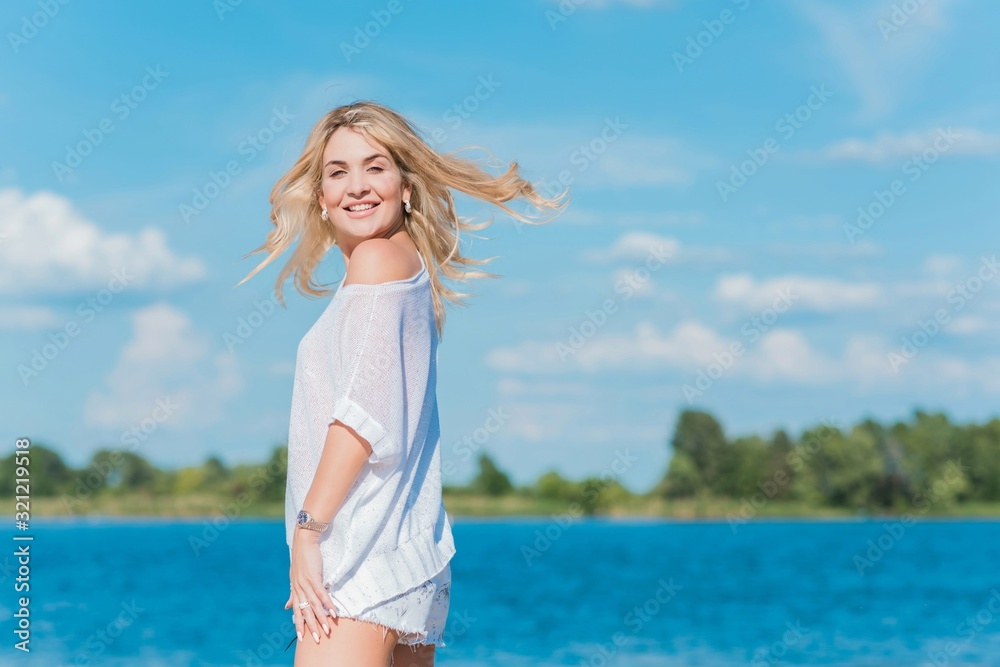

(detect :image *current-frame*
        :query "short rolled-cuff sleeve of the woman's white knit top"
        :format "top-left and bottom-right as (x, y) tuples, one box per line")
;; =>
(330, 285), (405, 463)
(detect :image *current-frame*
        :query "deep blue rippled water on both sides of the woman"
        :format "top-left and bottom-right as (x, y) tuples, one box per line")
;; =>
(0, 518), (1000, 667)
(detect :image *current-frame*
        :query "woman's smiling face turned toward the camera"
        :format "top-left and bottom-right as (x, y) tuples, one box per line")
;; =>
(319, 127), (412, 247)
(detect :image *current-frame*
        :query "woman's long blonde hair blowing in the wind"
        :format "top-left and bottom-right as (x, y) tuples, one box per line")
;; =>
(237, 100), (569, 336)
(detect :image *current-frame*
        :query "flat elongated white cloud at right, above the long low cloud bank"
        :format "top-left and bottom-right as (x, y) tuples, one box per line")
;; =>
(712, 273), (883, 312)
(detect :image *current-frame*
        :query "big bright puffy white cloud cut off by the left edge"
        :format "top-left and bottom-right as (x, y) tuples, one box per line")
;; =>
(0, 188), (207, 294)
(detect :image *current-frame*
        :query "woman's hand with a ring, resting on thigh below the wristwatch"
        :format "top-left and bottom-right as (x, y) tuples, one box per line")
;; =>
(285, 528), (336, 644)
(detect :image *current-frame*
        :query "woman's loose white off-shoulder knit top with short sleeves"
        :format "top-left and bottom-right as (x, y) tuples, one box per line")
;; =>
(285, 257), (455, 613)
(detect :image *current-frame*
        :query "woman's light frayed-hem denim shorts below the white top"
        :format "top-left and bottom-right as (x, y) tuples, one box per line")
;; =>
(330, 562), (451, 650)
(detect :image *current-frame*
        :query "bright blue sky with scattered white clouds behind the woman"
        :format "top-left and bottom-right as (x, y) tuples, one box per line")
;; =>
(0, 0), (1000, 491)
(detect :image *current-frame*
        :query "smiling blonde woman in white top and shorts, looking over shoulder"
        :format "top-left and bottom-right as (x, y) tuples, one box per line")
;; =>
(237, 101), (568, 667)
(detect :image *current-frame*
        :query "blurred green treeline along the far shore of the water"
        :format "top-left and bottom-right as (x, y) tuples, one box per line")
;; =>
(0, 410), (1000, 517)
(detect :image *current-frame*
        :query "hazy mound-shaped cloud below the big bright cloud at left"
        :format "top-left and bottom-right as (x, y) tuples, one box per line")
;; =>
(85, 303), (243, 429)
